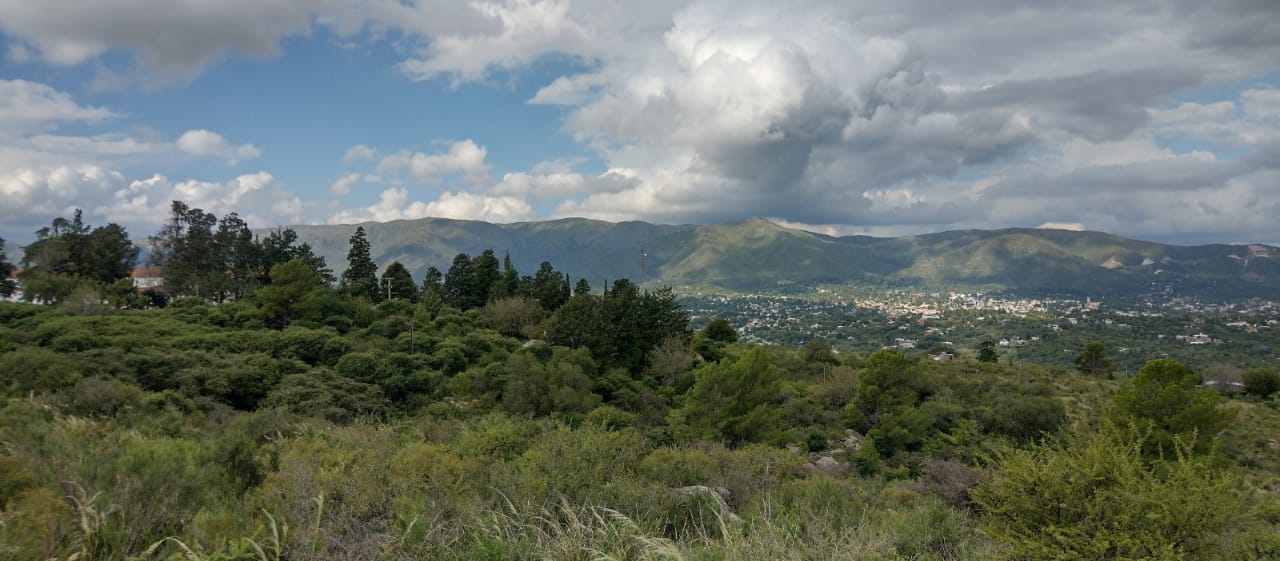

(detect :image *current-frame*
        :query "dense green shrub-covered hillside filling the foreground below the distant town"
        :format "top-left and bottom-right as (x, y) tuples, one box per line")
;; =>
(0, 203), (1280, 560)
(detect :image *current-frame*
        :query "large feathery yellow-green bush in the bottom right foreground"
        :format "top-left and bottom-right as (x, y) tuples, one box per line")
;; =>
(973, 427), (1244, 560)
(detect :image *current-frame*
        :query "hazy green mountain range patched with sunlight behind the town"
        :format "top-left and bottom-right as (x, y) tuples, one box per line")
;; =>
(282, 218), (1280, 298)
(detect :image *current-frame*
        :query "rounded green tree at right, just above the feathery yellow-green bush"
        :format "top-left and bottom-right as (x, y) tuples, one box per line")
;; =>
(1115, 359), (1235, 453)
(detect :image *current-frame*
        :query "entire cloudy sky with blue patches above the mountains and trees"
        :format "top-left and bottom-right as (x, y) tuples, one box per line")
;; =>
(0, 0), (1280, 247)
